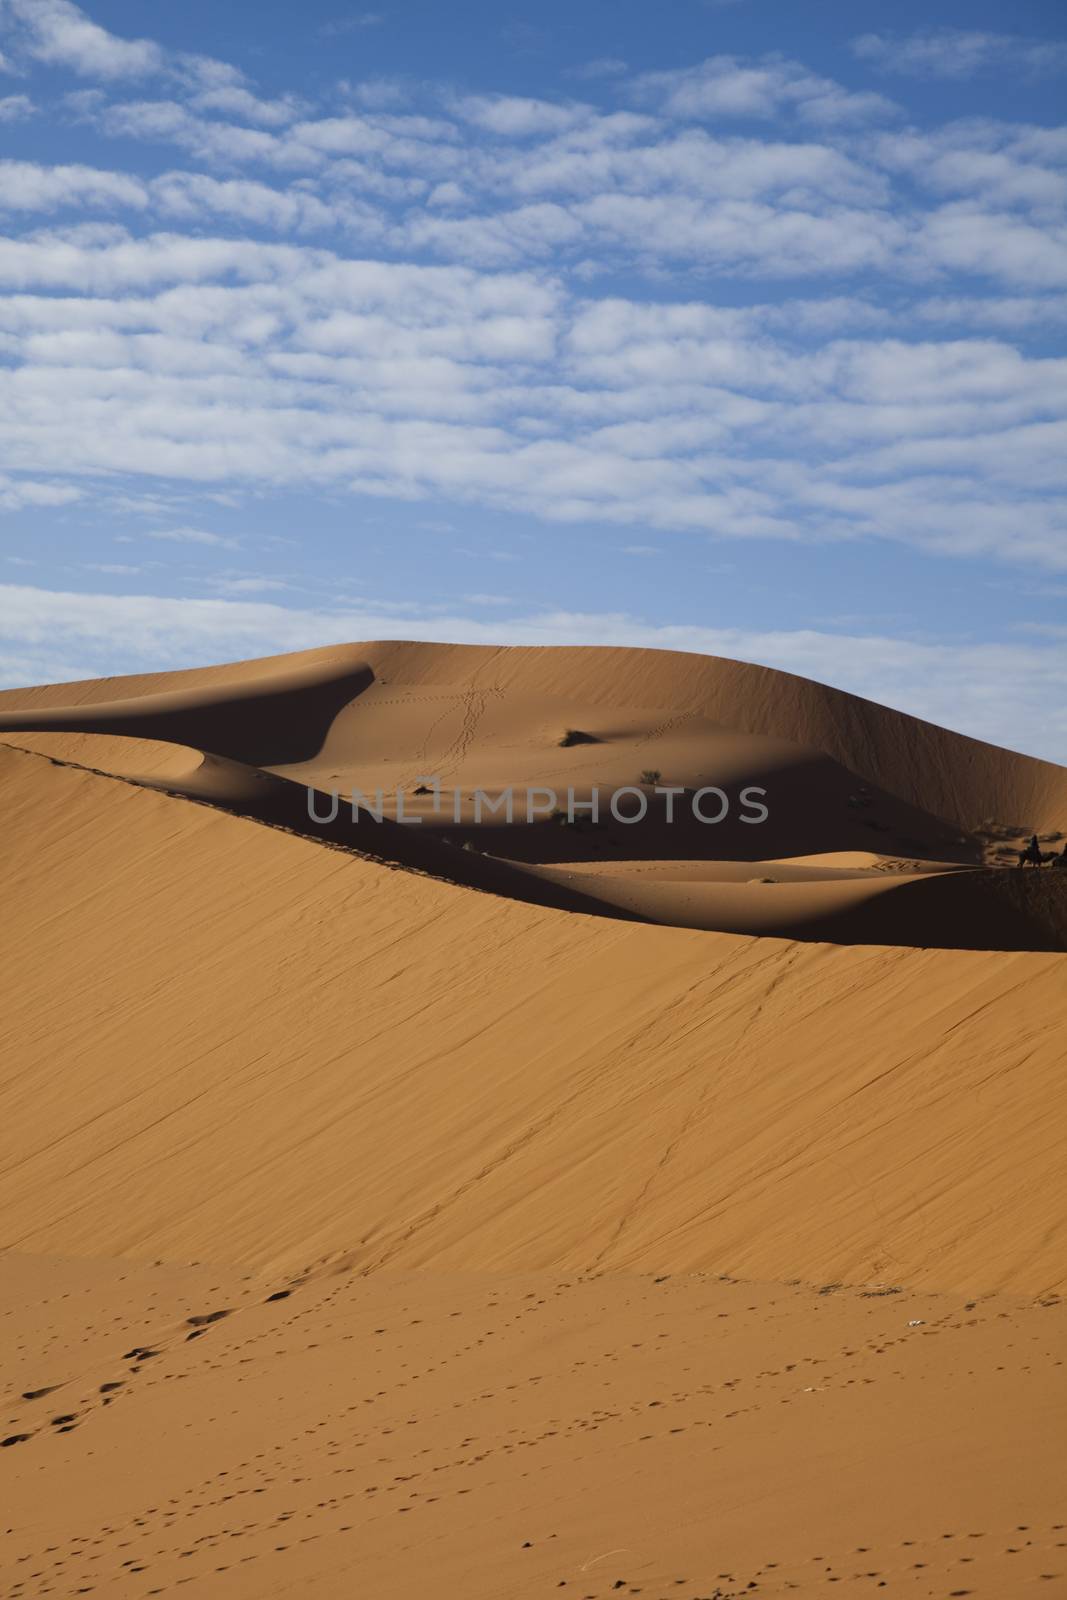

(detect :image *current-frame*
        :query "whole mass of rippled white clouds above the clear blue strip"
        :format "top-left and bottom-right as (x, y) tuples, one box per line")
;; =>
(0, 9), (1067, 688)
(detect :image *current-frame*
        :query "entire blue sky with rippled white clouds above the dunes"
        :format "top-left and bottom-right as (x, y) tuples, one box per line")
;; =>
(0, 0), (1067, 762)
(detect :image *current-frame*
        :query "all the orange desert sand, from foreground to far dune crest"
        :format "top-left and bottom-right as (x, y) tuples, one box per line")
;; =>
(0, 642), (1067, 1600)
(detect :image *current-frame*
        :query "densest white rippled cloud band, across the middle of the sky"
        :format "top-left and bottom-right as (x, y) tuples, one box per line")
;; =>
(0, 229), (1067, 568)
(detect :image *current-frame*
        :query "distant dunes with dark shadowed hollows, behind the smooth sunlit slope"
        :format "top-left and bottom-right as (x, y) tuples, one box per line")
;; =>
(0, 643), (1067, 950)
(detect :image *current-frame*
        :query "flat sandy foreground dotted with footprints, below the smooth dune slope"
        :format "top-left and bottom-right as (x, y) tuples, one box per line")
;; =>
(0, 1254), (1067, 1600)
